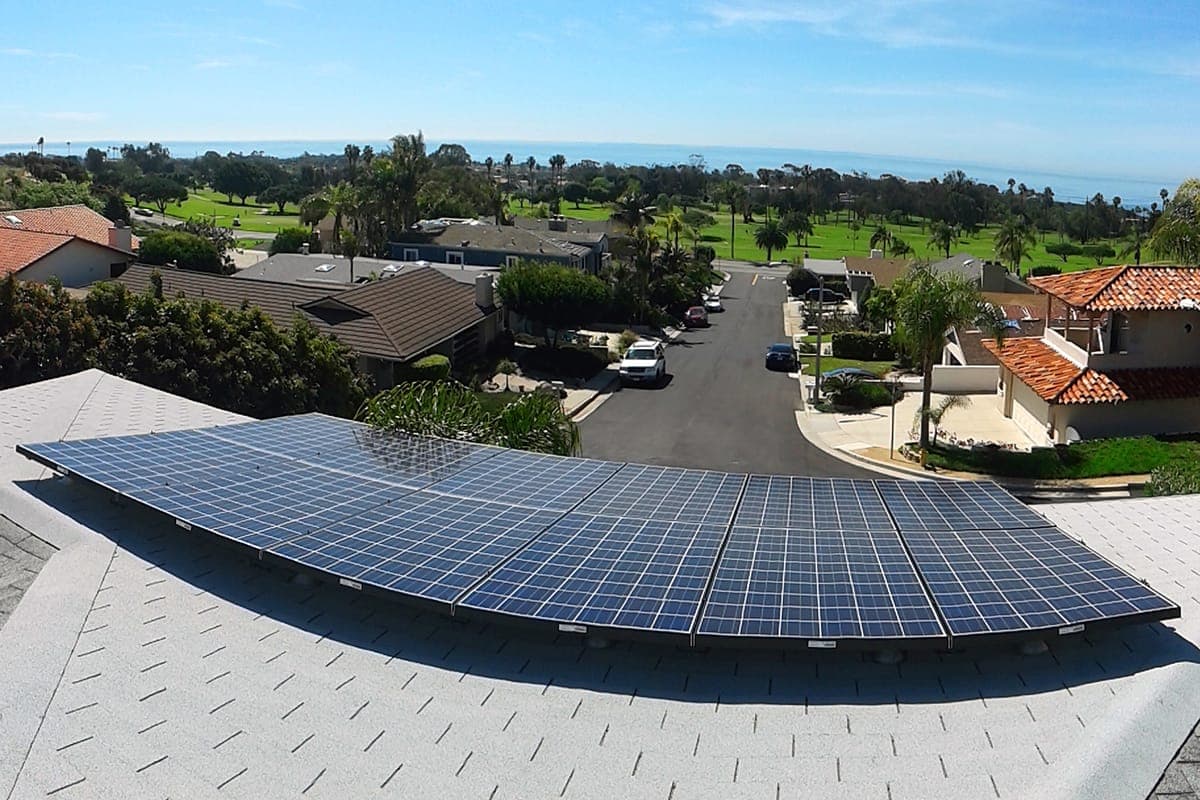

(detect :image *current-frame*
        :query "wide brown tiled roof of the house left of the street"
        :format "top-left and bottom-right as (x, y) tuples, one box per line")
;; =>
(111, 264), (486, 361)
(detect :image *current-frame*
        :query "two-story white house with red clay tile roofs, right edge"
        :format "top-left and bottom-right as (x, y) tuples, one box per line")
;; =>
(986, 266), (1200, 444)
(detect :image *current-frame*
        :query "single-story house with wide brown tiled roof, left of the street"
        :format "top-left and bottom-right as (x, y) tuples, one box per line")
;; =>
(118, 264), (500, 387)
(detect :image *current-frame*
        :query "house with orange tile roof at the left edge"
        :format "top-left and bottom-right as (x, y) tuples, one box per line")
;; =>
(0, 227), (133, 287)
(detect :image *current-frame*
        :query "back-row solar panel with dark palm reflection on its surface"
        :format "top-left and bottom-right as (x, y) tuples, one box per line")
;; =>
(203, 414), (494, 489)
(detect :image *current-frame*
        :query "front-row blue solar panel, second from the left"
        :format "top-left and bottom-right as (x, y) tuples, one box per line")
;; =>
(269, 492), (560, 602)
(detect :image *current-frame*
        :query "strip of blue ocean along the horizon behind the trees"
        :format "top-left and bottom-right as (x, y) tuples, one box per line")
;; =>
(0, 139), (1182, 209)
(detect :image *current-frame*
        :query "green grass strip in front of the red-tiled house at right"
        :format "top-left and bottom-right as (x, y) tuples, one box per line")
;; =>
(926, 437), (1200, 480)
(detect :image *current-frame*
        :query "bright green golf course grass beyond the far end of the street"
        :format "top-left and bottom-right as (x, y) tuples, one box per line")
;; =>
(509, 201), (1132, 273)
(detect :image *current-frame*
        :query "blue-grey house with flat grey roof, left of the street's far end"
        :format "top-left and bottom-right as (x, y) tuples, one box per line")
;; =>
(391, 219), (611, 275)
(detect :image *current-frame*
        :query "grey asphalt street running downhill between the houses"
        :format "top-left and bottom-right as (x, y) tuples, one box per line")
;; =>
(581, 270), (877, 477)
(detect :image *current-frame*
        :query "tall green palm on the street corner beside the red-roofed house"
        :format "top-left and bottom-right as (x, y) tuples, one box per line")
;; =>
(893, 264), (1003, 449)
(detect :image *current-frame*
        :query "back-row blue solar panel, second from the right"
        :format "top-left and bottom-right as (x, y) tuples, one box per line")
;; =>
(733, 475), (895, 531)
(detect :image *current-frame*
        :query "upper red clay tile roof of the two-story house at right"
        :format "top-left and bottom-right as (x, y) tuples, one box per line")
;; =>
(1030, 266), (1200, 311)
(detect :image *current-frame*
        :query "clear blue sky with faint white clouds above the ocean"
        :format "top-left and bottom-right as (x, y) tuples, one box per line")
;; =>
(0, 0), (1200, 179)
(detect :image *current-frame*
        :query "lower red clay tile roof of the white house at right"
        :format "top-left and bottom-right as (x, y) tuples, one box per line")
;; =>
(983, 338), (1200, 405)
